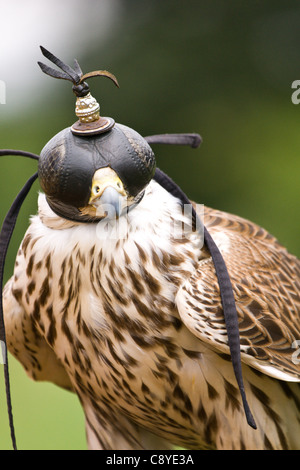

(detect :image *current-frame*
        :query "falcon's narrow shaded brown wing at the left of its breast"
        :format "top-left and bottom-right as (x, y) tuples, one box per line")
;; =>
(3, 277), (72, 390)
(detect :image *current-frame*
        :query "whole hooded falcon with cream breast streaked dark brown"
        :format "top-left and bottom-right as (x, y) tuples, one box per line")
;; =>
(3, 48), (300, 450)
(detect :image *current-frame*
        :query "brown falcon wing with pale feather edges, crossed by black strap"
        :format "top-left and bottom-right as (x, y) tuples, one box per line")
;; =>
(176, 209), (300, 382)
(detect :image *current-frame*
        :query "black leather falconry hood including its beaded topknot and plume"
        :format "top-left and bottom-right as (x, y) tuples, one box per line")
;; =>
(38, 47), (155, 222)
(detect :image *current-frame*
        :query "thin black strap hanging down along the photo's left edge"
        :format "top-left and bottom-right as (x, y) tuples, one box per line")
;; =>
(0, 172), (38, 450)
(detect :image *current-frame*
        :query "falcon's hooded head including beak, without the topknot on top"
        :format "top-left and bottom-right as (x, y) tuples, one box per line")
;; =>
(38, 124), (155, 222)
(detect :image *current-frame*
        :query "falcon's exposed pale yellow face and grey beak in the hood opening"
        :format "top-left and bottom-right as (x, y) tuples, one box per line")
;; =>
(89, 167), (127, 219)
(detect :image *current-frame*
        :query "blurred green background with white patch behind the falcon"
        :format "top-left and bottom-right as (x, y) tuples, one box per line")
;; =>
(0, 0), (300, 449)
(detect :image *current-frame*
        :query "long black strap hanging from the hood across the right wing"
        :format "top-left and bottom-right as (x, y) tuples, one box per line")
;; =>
(154, 168), (256, 429)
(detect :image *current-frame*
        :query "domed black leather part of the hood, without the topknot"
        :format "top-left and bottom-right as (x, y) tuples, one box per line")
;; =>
(38, 124), (155, 208)
